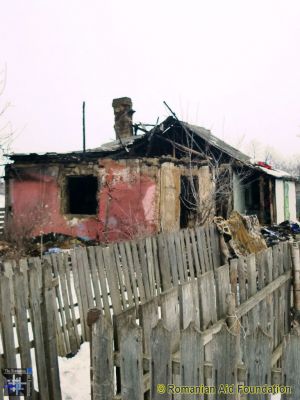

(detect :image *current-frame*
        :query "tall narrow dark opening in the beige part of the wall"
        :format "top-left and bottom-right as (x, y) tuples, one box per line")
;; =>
(180, 176), (199, 228)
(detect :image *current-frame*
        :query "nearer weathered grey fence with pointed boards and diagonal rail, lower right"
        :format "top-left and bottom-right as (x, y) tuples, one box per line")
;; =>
(88, 243), (292, 400)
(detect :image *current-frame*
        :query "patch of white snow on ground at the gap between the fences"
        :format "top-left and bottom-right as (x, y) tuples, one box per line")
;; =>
(58, 343), (91, 400)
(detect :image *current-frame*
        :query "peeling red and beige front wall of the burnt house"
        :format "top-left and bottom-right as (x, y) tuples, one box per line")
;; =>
(6, 158), (216, 242)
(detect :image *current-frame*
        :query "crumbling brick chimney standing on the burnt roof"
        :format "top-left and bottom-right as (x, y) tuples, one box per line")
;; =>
(112, 97), (134, 140)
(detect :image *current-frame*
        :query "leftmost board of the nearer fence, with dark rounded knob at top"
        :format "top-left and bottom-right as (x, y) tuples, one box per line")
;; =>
(87, 308), (114, 400)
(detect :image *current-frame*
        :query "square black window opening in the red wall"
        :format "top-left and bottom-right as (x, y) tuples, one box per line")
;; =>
(67, 175), (98, 215)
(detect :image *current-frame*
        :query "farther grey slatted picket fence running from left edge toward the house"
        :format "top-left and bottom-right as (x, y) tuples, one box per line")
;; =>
(0, 226), (220, 400)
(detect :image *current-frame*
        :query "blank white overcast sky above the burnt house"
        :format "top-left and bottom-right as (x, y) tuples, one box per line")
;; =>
(0, 0), (300, 155)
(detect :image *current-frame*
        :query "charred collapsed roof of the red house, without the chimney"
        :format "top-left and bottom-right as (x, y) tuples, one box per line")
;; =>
(9, 117), (250, 166)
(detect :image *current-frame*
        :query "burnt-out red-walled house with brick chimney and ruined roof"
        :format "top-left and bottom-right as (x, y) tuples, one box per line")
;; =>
(5, 98), (298, 242)
